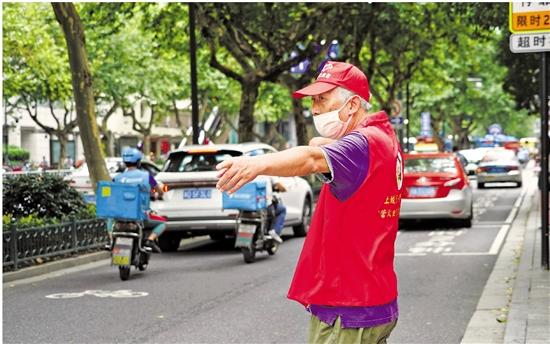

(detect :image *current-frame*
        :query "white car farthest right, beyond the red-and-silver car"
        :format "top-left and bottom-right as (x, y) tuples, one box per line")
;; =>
(477, 148), (522, 189)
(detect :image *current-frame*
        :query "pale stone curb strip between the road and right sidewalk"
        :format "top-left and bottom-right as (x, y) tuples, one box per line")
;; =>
(461, 173), (536, 344)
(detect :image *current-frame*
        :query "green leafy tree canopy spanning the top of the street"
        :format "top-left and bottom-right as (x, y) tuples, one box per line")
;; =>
(3, 3), (539, 156)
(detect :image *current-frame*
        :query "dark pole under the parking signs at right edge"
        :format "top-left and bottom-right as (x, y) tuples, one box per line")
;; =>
(540, 52), (549, 270)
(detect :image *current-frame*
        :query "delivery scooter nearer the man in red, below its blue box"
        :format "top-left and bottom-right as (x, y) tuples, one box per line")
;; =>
(235, 207), (279, 264)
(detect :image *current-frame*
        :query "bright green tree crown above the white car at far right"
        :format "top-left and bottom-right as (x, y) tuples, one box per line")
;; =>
(411, 27), (527, 149)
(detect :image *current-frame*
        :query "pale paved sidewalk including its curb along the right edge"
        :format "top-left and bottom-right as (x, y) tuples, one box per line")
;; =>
(462, 171), (550, 344)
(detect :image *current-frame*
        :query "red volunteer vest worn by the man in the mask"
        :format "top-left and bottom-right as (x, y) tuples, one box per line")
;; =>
(288, 112), (403, 307)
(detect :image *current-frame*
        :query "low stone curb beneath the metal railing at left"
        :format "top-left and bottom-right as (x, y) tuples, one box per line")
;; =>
(2, 251), (111, 283)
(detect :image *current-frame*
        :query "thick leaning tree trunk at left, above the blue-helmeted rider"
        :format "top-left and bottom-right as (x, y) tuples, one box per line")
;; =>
(52, 3), (110, 191)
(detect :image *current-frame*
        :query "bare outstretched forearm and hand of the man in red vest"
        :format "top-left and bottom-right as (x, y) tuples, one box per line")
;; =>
(216, 146), (329, 193)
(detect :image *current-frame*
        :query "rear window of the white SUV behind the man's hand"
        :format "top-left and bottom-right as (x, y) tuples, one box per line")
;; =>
(163, 151), (242, 172)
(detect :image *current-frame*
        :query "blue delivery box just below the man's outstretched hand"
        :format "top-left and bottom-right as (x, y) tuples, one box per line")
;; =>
(222, 181), (267, 211)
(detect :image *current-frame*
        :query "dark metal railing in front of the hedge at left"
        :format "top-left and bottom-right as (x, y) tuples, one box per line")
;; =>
(2, 219), (109, 270)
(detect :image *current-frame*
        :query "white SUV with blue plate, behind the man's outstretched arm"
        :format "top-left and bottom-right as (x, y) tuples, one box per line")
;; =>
(151, 143), (313, 251)
